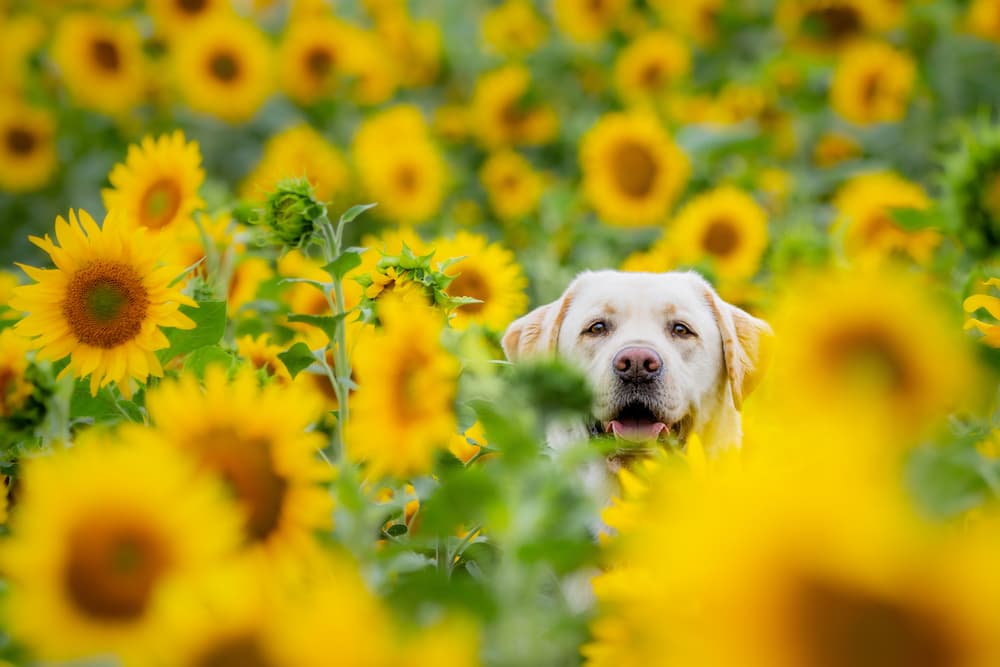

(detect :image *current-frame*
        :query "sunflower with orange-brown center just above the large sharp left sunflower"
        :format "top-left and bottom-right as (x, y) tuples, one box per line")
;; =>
(101, 130), (205, 235)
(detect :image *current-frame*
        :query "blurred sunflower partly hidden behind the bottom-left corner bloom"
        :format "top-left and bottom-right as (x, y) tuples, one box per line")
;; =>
(146, 366), (332, 563)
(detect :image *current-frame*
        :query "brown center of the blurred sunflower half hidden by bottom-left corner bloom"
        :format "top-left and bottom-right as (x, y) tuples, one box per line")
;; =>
(195, 427), (288, 541)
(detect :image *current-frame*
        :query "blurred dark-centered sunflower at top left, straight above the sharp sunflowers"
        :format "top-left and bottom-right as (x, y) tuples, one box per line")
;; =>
(52, 14), (146, 115)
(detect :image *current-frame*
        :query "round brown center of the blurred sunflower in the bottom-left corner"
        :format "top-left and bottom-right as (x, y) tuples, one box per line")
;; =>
(63, 516), (170, 621)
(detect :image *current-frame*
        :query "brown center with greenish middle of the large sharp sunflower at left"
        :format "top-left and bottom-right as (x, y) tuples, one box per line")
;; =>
(62, 259), (149, 350)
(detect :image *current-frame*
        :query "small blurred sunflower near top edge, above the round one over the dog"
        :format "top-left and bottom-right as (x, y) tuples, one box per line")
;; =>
(614, 30), (691, 102)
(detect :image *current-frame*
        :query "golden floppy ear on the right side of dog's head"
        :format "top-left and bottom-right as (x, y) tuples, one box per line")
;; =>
(705, 287), (774, 409)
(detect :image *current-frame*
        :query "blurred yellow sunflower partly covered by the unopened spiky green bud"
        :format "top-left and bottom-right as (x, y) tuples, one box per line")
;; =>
(240, 125), (349, 202)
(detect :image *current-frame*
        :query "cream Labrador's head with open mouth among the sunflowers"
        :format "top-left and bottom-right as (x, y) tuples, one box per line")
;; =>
(503, 271), (772, 454)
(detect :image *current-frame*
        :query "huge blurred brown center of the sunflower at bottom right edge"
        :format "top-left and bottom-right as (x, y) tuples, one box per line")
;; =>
(791, 578), (966, 667)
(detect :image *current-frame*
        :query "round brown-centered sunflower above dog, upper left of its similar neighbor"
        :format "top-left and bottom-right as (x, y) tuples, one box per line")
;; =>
(580, 113), (690, 227)
